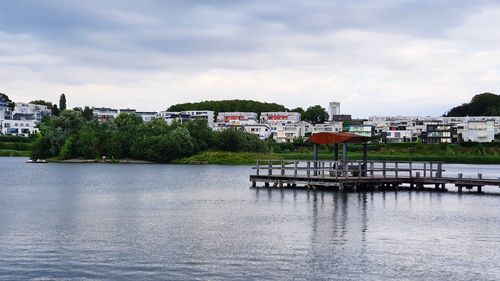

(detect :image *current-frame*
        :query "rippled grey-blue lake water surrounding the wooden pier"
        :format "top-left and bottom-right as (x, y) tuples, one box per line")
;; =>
(0, 158), (500, 280)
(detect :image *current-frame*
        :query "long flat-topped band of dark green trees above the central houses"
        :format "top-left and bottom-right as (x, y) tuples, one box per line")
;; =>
(167, 100), (289, 115)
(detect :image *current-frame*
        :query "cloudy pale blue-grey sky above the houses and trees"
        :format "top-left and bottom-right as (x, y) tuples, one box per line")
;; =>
(0, 0), (500, 117)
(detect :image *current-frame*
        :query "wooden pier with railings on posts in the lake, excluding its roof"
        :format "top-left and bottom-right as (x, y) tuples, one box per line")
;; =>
(250, 159), (500, 193)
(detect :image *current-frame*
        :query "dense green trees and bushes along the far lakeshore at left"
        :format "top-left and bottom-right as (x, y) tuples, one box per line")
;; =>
(31, 110), (269, 162)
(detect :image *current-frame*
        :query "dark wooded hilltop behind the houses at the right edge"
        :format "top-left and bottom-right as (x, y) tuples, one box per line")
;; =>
(445, 93), (500, 117)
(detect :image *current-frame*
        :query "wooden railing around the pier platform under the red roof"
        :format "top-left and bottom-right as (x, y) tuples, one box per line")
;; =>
(253, 160), (443, 178)
